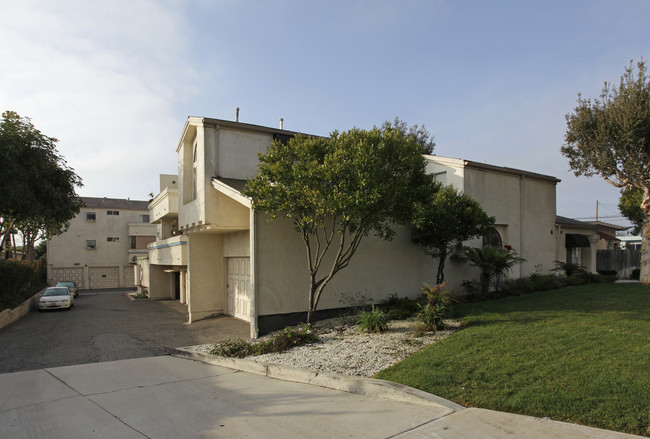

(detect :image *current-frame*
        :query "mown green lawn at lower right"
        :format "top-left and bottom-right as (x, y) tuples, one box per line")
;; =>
(377, 284), (650, 437)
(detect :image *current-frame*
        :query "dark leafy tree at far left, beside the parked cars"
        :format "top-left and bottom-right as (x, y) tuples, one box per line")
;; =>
(0, 111), (82, 257)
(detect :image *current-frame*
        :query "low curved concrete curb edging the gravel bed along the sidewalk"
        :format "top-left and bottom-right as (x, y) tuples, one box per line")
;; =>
(171, 348), (465, 416)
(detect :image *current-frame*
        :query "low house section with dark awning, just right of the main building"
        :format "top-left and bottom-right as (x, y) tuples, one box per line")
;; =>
(555, 215), (601, 273)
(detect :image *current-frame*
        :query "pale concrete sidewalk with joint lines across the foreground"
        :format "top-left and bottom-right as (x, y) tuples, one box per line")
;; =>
(0, 356), (635, 439)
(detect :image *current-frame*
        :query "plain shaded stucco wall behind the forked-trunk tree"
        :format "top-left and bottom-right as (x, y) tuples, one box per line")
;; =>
(255, 214), (435, 315)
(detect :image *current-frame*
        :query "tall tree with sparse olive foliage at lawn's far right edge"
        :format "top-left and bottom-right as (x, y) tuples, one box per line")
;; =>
(562, 60), (650, 285)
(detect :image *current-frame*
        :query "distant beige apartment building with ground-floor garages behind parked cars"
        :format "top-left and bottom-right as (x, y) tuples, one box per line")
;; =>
(47, 197), (156, 289)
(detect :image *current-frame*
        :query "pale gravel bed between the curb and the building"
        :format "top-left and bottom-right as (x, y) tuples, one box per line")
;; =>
(193, 317), (459, 377)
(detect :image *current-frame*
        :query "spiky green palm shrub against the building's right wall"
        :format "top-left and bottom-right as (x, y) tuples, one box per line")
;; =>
(463, 247), (526, 294)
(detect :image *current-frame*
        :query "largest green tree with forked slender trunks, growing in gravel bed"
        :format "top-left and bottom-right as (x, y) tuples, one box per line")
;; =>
(244, 126), (431, 323)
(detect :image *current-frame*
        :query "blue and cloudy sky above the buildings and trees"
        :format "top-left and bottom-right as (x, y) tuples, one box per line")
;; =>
(0, 0), (650, 225)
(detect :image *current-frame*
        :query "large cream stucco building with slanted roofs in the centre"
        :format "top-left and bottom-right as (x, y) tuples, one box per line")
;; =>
(138, 117), (559, 337)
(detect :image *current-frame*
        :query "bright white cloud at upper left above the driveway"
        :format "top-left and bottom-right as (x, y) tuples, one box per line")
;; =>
(0, 1), (198, 199)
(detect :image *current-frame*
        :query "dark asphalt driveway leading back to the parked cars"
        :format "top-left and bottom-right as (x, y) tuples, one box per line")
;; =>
(0, 290), (248, 373)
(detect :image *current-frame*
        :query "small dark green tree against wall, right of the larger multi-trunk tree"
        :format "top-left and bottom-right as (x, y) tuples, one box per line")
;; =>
(411, 186), (494, 284)
